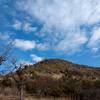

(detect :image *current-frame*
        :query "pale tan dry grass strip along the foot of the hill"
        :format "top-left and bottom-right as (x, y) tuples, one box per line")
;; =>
(0, 88), (71, 100)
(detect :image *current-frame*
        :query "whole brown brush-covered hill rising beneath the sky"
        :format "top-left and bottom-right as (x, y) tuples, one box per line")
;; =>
(0, 59), (100, 100)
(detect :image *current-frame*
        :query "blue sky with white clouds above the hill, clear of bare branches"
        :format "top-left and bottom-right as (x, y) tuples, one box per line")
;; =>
(0, 0), (100, 67)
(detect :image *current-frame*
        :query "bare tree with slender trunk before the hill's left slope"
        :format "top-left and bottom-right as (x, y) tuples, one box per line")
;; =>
(9, 59), (26, 100)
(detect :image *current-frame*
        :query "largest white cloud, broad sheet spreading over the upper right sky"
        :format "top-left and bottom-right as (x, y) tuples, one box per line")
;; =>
(17, 0), (100, 52)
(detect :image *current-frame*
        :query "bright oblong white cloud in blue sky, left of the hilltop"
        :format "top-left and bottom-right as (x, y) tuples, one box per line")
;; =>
(14, 39), (36, 51)
